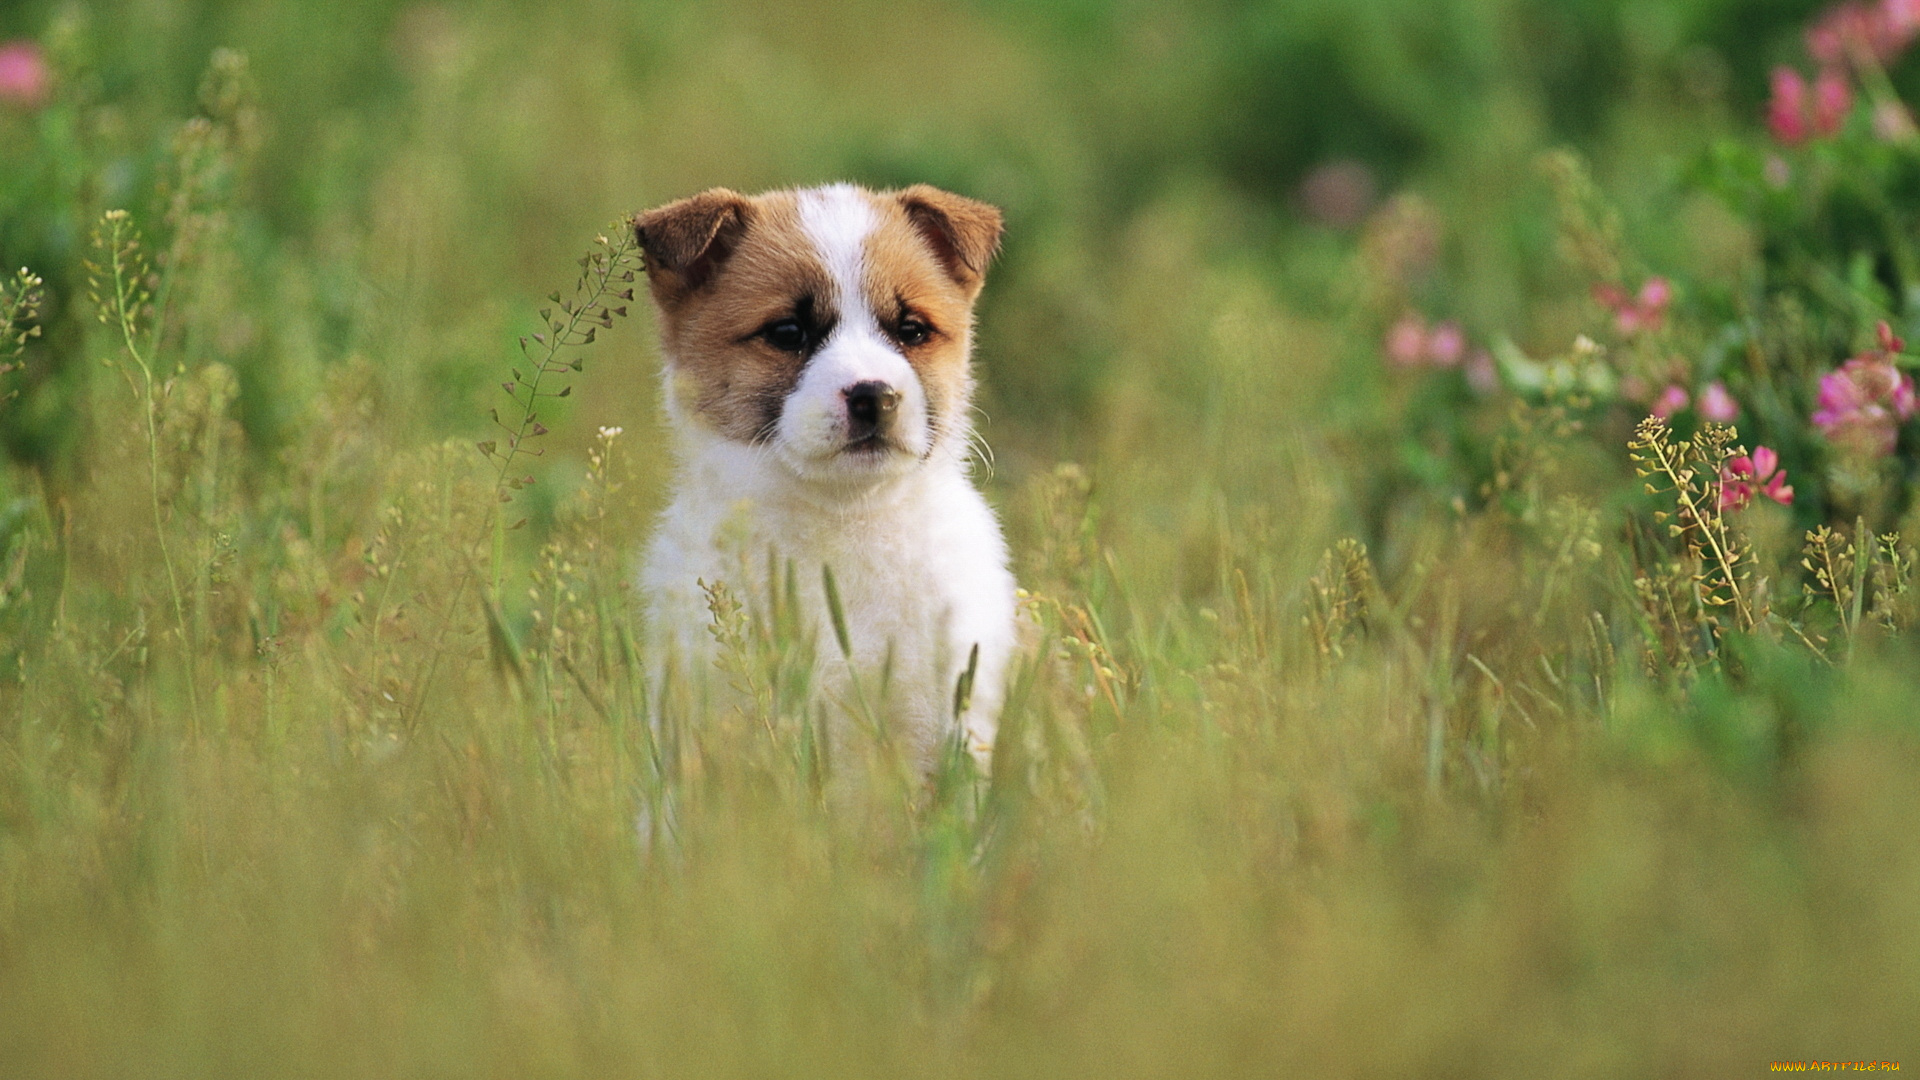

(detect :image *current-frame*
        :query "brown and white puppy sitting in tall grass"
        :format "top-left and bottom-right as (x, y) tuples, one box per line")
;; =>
(634, 184), (1016, 769)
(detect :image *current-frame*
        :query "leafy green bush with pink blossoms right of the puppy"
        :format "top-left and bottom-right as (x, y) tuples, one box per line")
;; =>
(1380, 0), (1920, 523)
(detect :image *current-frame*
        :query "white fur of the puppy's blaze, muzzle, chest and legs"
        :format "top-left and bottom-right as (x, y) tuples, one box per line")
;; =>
(641, 186), (1016, 767)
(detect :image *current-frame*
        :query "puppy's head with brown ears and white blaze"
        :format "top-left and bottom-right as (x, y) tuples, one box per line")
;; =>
(634, 184), (1000, 480)
